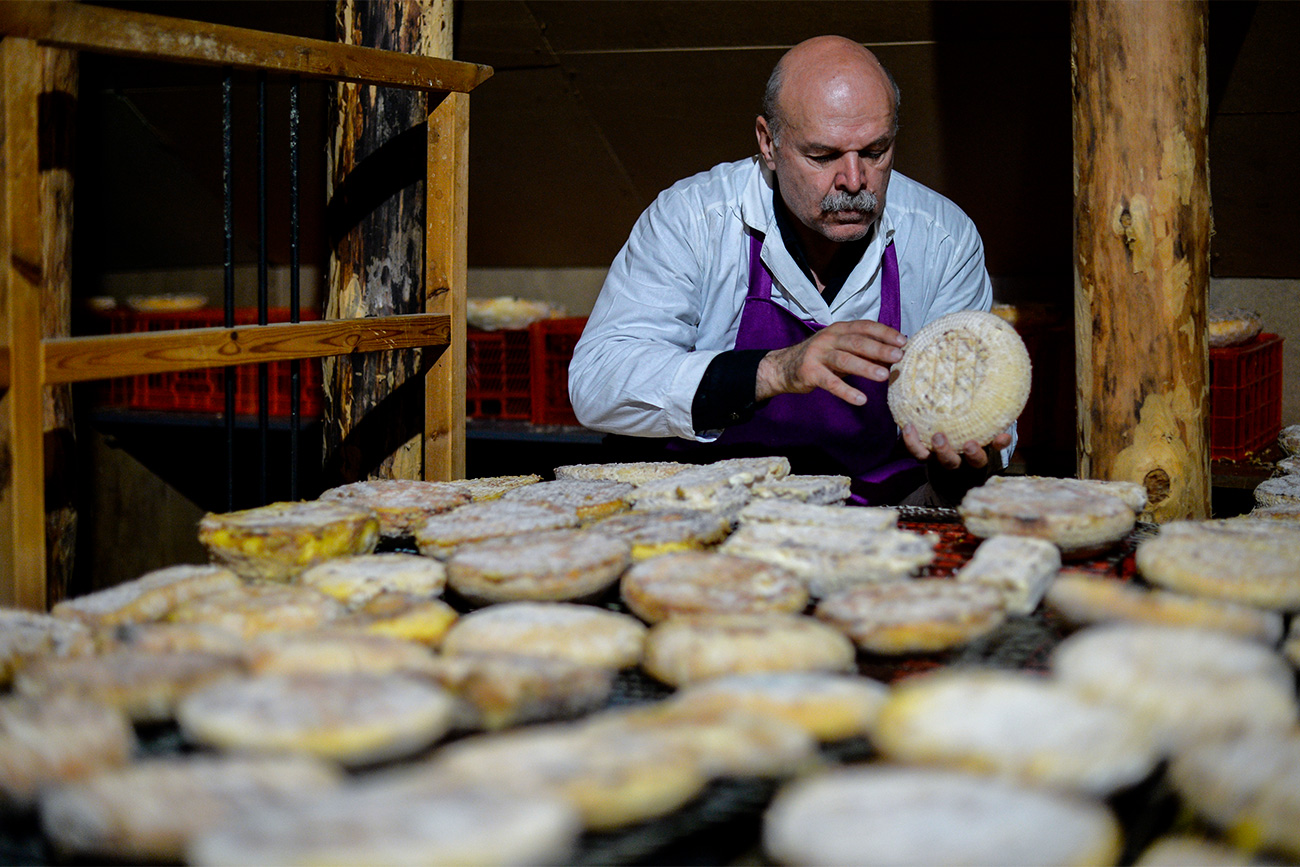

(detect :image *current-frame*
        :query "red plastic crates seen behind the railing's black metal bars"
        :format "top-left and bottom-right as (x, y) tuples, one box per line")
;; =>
(94, 307), (324, 416)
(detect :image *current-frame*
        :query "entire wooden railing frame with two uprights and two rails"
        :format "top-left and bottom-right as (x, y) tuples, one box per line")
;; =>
(0, 1), (491, 610)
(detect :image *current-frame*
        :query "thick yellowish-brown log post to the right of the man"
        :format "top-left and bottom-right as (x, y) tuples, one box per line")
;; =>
(1071, 0), (1210, 523)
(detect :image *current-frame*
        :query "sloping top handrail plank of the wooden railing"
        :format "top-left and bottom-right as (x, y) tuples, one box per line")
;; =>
(0, 0), (493, 92)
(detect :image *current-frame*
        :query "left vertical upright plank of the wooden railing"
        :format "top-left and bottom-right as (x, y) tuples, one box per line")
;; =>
(0, 39), (46, 611)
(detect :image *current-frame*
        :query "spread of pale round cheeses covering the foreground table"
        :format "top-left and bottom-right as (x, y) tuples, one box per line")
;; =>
(10, 447), (1300, 864)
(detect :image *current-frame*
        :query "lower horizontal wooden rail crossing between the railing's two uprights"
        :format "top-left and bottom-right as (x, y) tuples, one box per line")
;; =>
(38, 313), (451, 384)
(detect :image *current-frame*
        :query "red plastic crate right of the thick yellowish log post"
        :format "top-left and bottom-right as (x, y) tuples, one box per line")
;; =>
(1210, 334), (1282, 459)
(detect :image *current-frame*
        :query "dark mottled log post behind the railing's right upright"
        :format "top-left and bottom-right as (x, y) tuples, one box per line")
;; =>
(324, 0), (451, 484)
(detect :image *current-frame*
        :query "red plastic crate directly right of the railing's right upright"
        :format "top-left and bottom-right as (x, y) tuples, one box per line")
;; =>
(465, 328), (532, 421)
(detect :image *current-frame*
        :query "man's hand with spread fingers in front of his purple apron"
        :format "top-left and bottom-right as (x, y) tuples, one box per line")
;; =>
(754, 320), (907, 407)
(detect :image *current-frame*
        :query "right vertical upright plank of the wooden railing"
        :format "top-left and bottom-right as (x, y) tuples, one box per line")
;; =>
(424, 94), (469, 481)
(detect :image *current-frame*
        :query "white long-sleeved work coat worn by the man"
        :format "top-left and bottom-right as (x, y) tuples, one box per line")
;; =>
(569, 156), (993, 442)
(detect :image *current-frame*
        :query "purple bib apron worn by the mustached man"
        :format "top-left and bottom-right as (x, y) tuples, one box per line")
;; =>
(696, 235), (926, 506)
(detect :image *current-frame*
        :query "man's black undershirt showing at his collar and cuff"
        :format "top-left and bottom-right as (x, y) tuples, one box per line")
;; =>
(690, 190), (874, 433)
